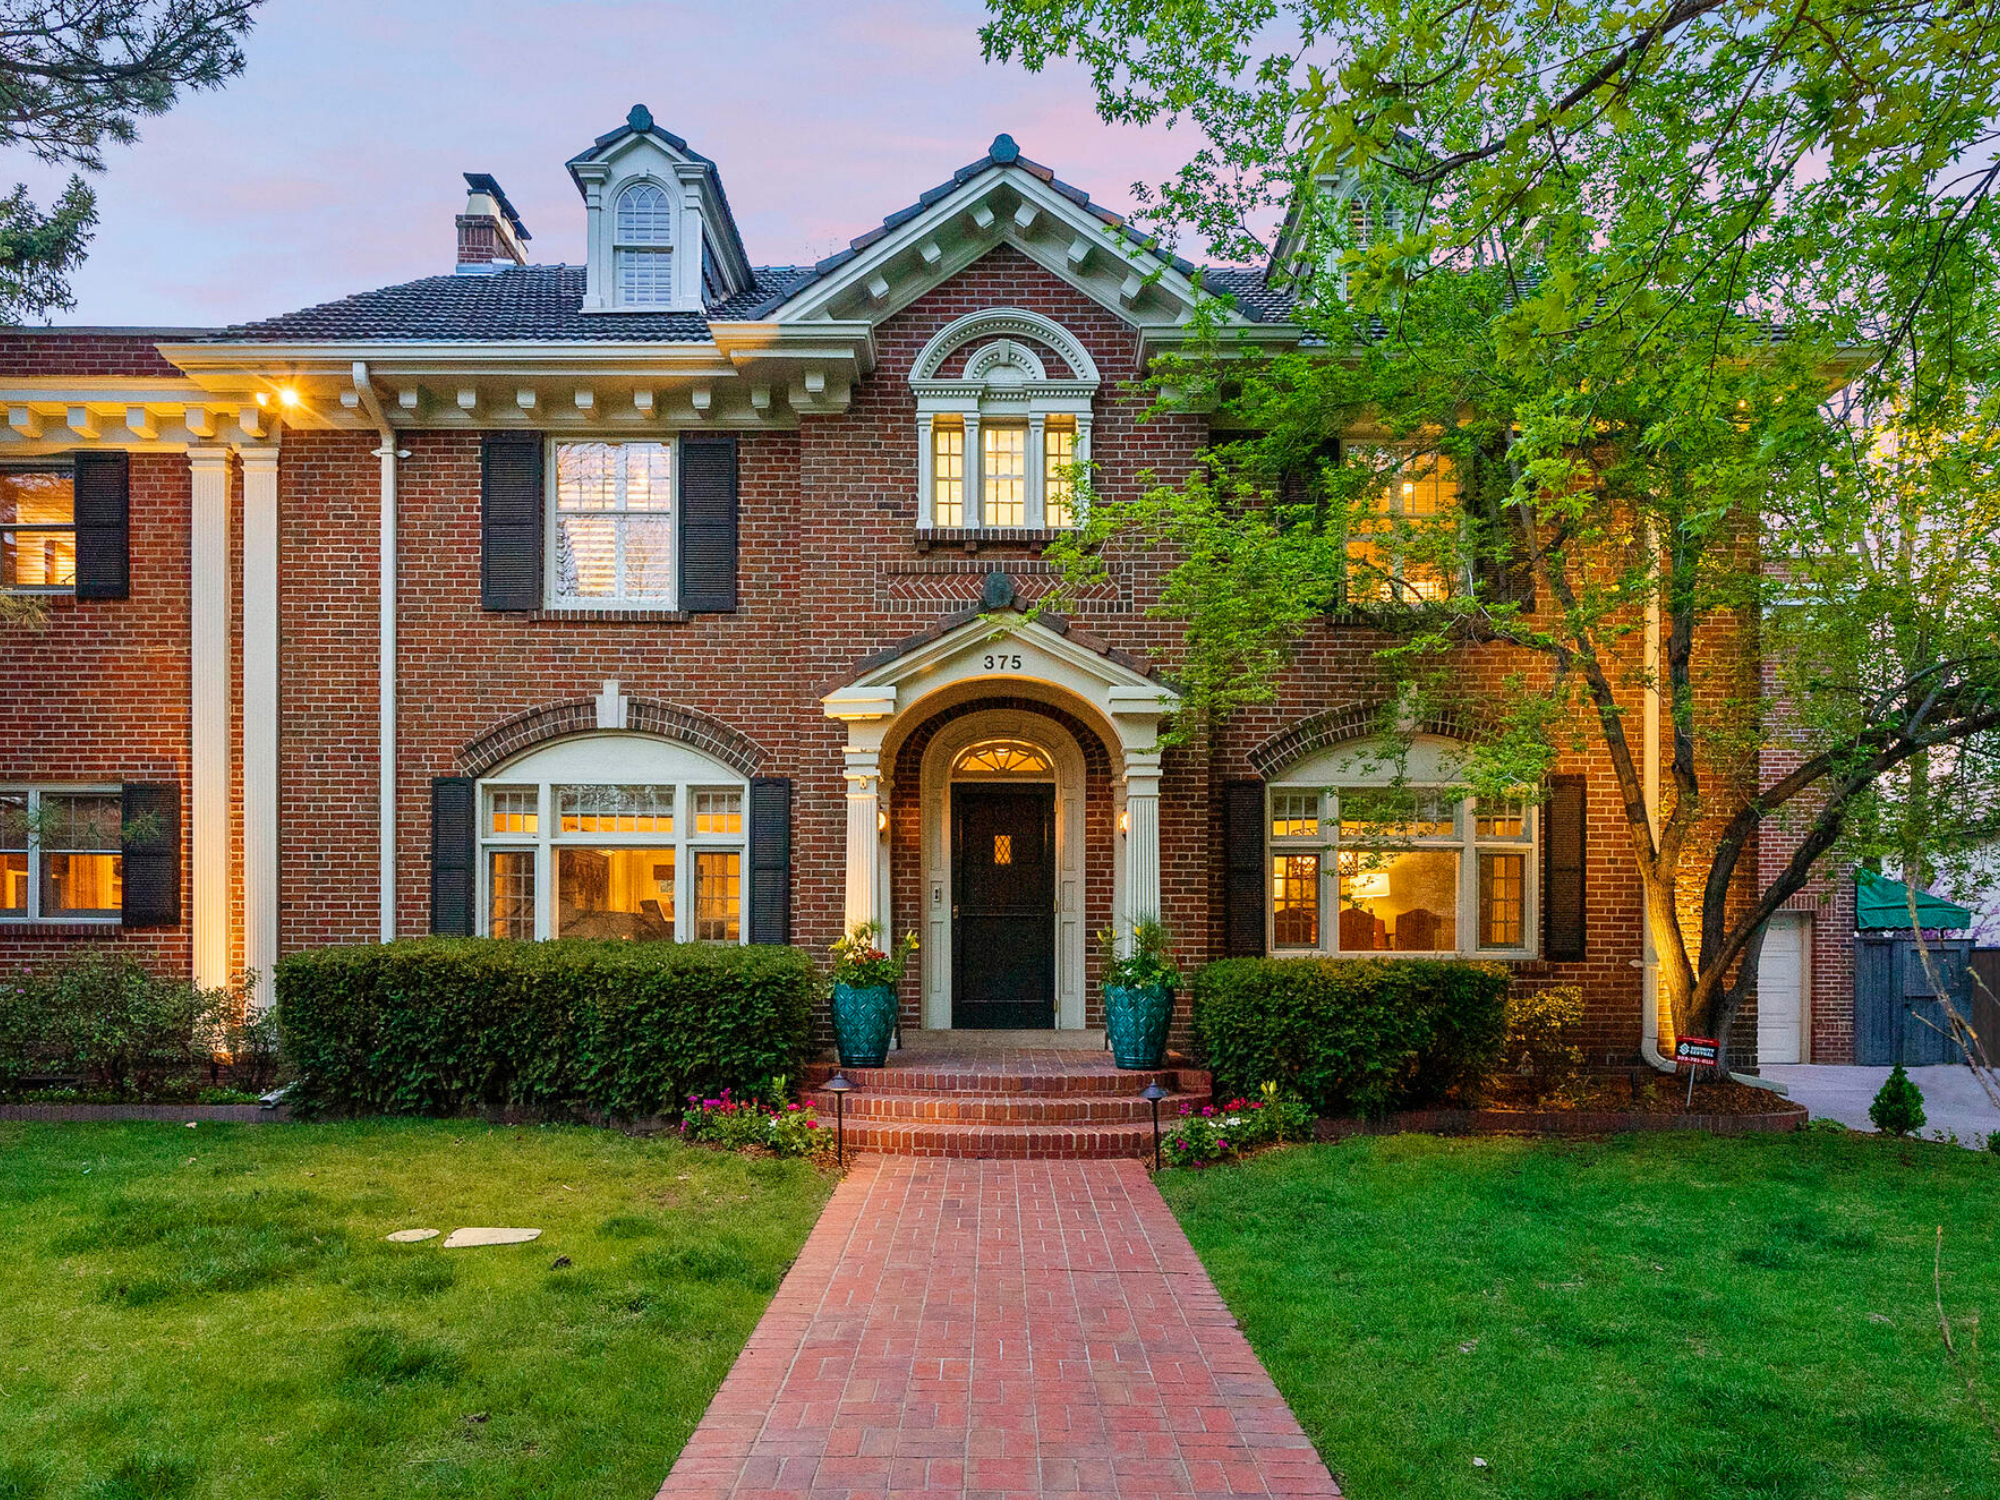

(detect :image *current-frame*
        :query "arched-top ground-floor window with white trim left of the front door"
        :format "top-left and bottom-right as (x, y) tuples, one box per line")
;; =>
(480, 734), (748, 942)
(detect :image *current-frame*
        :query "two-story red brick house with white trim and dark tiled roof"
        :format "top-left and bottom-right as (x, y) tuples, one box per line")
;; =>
(0, 108), (1720, 1062)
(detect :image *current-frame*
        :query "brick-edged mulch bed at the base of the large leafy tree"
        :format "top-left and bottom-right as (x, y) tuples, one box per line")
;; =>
(1316, 1074), (1810, 1140)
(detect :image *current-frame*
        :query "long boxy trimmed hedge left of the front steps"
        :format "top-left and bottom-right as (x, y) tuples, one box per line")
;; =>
(278, 938), (818, 1120)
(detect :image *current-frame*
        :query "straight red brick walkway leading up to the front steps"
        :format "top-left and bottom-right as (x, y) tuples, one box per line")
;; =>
(660, 1158), (1338, 1500)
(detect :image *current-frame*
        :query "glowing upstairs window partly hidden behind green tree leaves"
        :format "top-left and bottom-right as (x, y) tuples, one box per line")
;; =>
(1348, 442), (1460, 606)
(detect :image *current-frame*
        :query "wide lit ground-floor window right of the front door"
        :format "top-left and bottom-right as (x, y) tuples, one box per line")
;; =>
(1268, 784), (1534, 956)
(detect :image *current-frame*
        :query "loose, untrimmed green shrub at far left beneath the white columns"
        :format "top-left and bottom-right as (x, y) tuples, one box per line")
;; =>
(0, 948), (242, 1100)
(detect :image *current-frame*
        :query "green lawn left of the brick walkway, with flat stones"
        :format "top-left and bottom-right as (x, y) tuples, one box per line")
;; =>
(0, 1122), (832, 1500)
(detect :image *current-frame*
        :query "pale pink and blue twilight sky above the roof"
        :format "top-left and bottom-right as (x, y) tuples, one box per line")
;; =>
(11, 0), (1198, 326)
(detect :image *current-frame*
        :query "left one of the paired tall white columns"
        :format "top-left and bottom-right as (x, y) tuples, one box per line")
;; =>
(188, 448), (230, 990)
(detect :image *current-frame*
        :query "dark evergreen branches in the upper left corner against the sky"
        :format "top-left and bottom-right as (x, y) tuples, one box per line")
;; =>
(0, 0), (262, 322)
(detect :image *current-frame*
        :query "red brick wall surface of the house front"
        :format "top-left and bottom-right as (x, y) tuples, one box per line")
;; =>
(0, 244), (1784, 1062)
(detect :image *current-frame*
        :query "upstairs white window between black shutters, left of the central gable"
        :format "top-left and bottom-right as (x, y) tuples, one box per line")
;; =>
(548, 442), (678, 610)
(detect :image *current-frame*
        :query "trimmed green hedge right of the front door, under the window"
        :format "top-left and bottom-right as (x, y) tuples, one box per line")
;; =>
(1194, 958), (1508, 1116)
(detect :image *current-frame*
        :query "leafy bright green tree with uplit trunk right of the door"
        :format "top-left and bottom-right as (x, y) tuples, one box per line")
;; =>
(984, 0), (2000, 1062)
